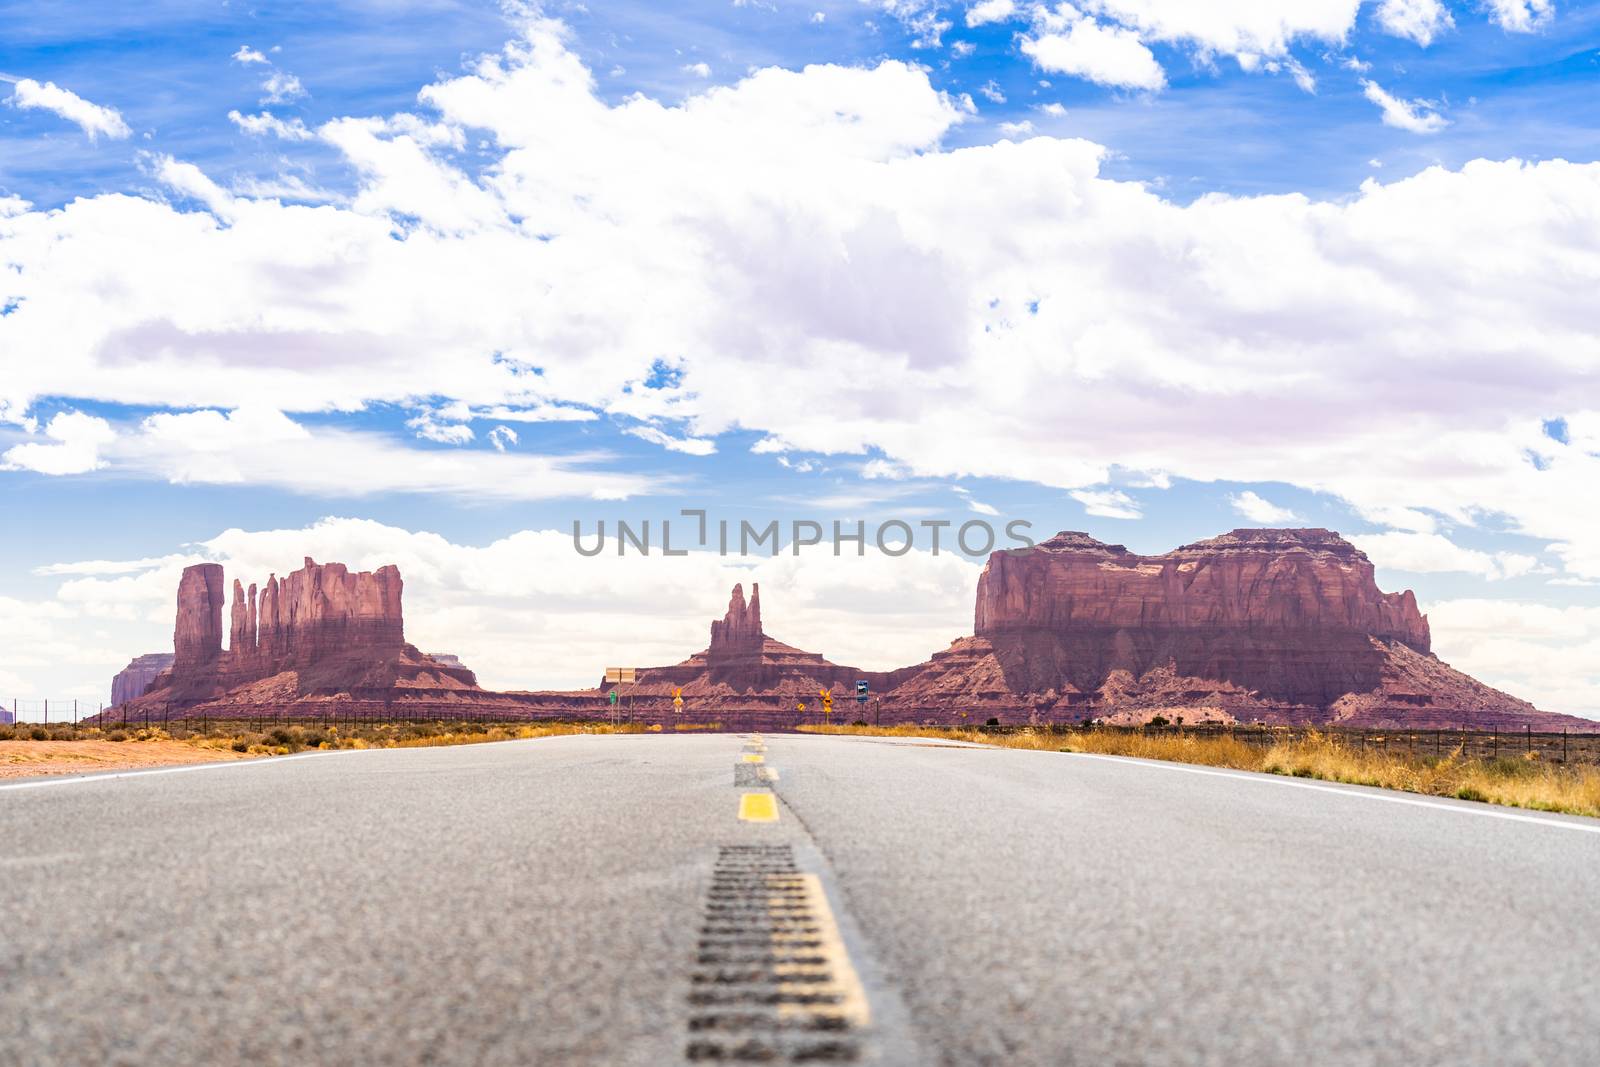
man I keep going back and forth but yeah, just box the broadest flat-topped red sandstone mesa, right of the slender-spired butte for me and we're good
[885,530,1595,729]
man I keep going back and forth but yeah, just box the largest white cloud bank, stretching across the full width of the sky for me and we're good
[0,21,1600,577]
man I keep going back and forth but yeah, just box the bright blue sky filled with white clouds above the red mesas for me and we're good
[0,0,1600,715]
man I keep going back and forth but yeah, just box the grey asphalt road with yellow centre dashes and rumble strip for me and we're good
[0,736,1600,1065]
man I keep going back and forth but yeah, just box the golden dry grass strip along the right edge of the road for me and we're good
[803,726,1600,816]
